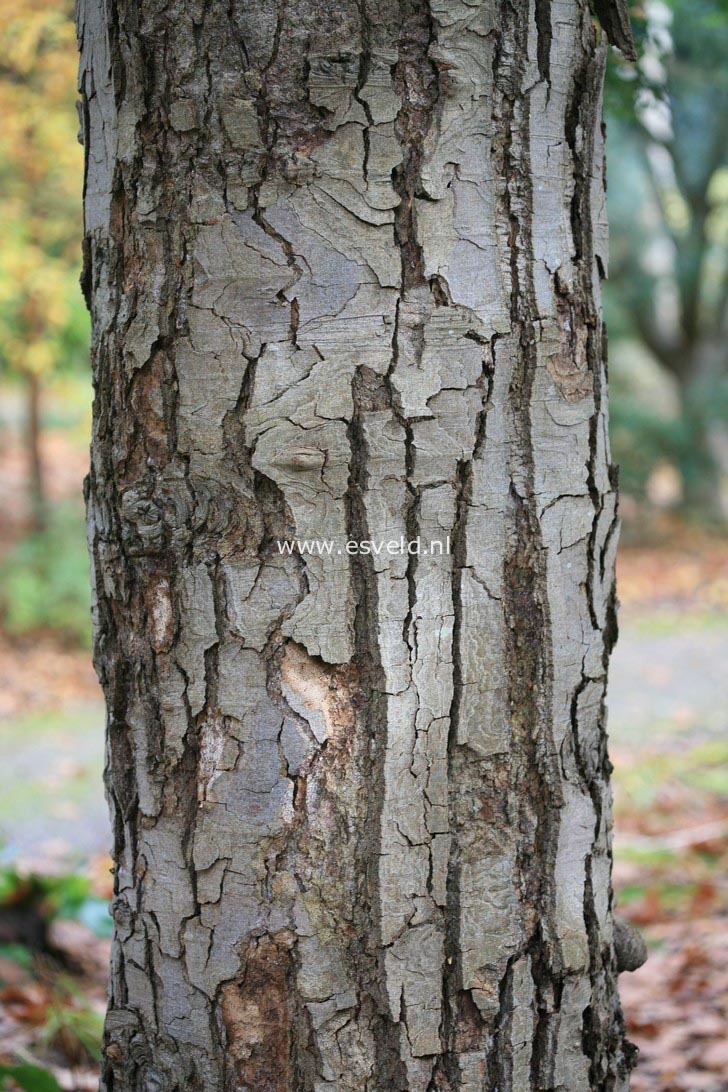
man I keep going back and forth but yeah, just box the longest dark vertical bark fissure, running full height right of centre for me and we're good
[494,3,562,1089]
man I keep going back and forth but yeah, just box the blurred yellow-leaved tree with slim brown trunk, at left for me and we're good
[0,0,88,527]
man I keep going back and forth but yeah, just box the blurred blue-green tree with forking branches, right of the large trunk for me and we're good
[608,0,728,520]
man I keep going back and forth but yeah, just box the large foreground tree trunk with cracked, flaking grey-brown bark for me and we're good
[80,0,630,1092]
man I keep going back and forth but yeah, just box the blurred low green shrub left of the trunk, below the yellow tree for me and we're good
[0,505,91,648]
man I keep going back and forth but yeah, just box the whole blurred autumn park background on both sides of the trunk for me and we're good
[0,0,728,1092]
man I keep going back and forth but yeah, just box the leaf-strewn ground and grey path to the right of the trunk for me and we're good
[608,543,728,1092]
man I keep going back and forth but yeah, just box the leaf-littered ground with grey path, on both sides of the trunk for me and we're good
[0,395,728,1092]
